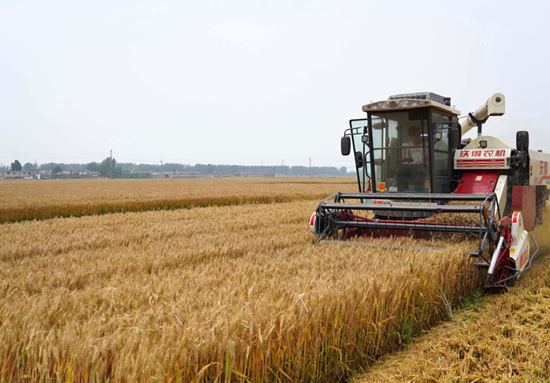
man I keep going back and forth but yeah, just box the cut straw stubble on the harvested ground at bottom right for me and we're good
[354,205,550,383]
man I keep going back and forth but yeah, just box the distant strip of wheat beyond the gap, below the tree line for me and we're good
[0,178,357,223]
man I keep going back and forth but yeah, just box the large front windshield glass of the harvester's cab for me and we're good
[371,109,430,192]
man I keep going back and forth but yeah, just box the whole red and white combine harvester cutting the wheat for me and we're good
[310,93,550,289]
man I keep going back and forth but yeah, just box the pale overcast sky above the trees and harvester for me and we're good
[0,0,550,168]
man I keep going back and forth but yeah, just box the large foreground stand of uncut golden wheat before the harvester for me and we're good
[0,180,479,382]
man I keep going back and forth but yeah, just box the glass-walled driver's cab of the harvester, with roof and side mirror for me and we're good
[342,93,460,198]
